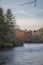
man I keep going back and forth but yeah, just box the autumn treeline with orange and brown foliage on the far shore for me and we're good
[17,27,43,44]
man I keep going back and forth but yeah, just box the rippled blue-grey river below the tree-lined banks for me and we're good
[0,44,43,65]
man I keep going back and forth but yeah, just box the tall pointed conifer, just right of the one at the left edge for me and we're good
[6,9,15,44]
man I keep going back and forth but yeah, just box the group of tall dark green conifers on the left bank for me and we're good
[0,7,16,47]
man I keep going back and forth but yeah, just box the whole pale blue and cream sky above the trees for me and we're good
[0,0,43,30]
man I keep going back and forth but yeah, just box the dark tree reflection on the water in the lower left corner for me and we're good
[0,50,14,65]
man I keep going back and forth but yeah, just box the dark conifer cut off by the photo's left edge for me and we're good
[0,7,5,46]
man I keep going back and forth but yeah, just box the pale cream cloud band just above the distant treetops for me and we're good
[17,19,43,30]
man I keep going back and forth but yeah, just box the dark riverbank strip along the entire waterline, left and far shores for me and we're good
[0,42,43,49]
